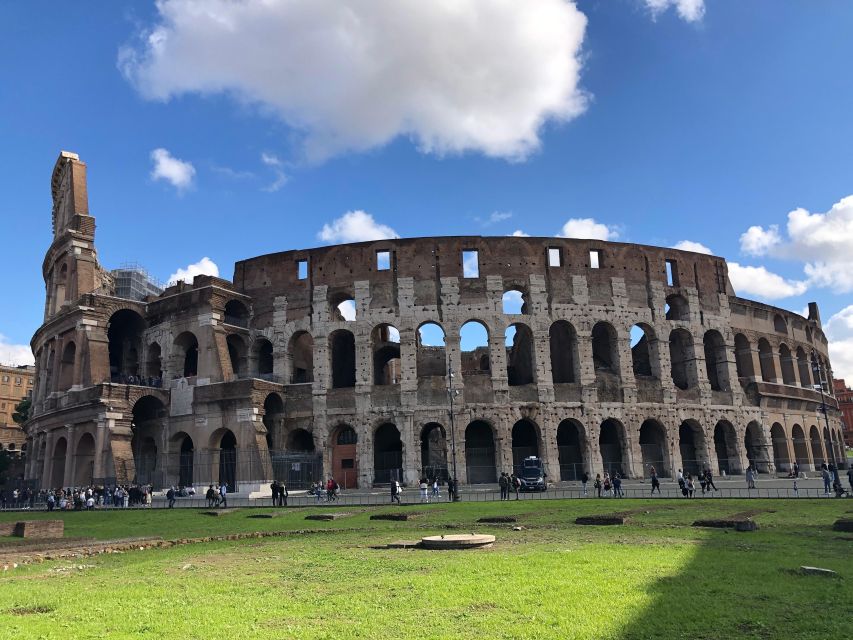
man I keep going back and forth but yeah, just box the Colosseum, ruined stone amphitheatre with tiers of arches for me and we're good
[20,152,845,492]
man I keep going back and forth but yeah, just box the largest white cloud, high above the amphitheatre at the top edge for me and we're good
[118,0,587,161]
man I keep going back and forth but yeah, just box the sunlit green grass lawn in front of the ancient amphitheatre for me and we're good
[0,499,853,640]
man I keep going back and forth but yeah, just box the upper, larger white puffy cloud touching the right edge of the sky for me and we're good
[741,195,853,293]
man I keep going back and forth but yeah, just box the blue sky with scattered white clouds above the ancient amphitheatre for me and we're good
[0,0,853,377]
